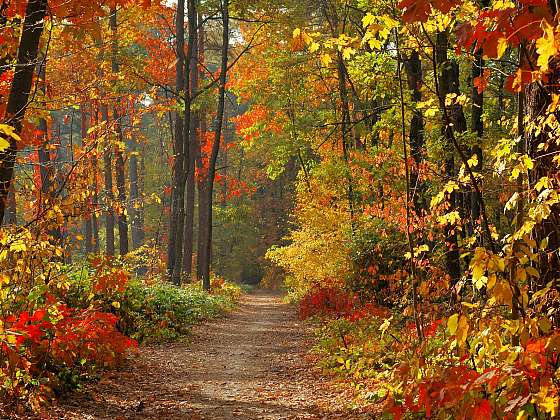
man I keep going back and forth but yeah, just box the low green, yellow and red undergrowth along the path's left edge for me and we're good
[0,228,241,412]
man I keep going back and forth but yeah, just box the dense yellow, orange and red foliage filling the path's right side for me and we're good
[235,0,560,419]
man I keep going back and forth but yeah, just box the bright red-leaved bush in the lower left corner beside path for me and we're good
[0,303,137,407]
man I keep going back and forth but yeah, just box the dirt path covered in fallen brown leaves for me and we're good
[40,291,369,420]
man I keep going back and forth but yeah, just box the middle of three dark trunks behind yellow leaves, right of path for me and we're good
[436,32,466,284]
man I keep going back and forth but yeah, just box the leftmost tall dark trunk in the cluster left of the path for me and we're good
[167,0,186,281]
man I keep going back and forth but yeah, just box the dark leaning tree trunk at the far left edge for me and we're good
[0,0,47,221]
